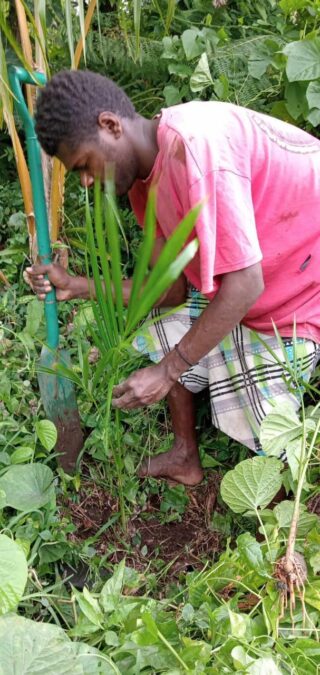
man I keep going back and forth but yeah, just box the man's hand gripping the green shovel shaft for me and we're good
[24,263,76,300]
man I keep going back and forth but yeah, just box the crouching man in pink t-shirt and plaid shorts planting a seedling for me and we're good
[28,71,320,485]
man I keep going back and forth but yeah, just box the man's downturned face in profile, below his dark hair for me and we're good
[58,115,138,196]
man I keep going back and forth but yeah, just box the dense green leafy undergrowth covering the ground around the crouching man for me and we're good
[0,0,320,675]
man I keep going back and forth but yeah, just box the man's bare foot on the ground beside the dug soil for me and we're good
[139,444,203,485]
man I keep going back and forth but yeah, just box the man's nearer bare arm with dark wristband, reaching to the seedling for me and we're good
[113,263,264,409]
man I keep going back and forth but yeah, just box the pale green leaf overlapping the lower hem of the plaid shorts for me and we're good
[260,403,303,456]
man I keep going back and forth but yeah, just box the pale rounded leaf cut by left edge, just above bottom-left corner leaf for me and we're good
[0,534,28,616]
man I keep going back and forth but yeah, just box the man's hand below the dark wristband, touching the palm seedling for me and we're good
[112,363,174,410]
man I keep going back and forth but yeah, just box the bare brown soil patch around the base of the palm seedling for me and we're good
[62,472,221,577]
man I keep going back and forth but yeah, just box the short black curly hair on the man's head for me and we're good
[35,70,136,156]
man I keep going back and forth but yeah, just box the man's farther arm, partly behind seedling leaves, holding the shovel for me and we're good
[26,237,187,307]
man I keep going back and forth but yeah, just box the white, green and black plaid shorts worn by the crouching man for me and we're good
[134,288,320,452]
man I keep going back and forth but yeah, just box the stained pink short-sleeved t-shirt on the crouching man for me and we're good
[129,101,320,342]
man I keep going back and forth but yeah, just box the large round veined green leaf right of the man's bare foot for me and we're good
[221,457,282,513]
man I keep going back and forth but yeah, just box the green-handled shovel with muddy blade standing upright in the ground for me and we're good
[9,66,83,473]
